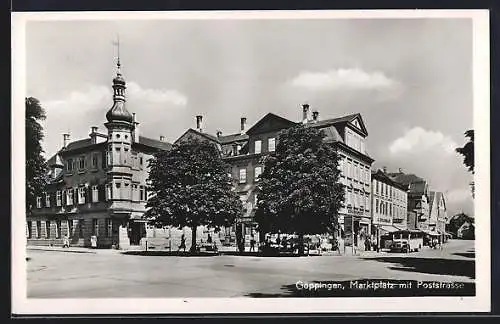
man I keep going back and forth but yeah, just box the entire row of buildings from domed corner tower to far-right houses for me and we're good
[26,59,446,249]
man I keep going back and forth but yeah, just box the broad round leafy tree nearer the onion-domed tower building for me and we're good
[146,139,243,253]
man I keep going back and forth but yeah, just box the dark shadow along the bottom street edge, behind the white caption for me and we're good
[245,279,476,298]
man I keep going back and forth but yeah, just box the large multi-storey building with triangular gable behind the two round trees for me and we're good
[175,104,374,244]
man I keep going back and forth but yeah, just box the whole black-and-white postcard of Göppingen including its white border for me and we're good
[12,10,490,314]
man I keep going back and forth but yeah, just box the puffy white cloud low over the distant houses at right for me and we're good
[389,127,458,154]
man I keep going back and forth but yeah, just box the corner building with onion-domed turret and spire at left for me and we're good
[26,63,171,249]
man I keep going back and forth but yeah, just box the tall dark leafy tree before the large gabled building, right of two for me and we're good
[256,124,344,255]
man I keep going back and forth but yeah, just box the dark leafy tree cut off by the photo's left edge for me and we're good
[25,97,47,213]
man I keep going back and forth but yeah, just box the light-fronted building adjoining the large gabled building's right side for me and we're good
[371,170,408,247]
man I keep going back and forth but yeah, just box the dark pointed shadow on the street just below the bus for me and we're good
[364,257,476,279]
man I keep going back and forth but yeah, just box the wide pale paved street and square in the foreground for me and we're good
[28,240,475,298]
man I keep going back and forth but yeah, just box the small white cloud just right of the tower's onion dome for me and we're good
[127,82,187,106]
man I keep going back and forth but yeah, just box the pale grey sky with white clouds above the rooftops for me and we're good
[26,18,473,215]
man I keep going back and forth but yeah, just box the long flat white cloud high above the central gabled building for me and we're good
[290,68,401,91]
